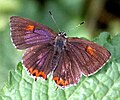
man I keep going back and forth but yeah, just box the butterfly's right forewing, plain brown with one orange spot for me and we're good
[67,38,111,76]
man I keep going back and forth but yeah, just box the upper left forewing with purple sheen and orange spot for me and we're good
[10,16,57,49]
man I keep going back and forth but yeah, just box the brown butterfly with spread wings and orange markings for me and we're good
[10,16,111,88]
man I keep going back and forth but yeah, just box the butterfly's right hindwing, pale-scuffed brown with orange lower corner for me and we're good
[53,50,82,88]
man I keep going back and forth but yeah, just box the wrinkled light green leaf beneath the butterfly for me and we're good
[0,32,120,100]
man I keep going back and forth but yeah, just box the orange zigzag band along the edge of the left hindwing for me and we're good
[29,67,47,79]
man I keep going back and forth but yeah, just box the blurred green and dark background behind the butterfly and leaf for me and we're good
[0,0,120,88]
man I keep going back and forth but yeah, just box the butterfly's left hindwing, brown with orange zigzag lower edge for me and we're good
[23,44,53,79]
